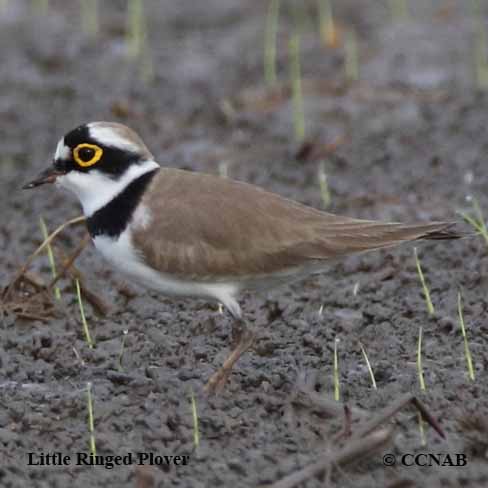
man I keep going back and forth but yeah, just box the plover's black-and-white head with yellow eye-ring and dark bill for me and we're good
[23,122,159,217]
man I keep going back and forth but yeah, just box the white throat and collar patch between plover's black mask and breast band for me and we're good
[56,160,159,217]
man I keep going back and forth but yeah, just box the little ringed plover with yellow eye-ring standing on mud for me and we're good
[23,122,460,393]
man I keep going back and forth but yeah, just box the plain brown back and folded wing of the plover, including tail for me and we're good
[134,168,458,281]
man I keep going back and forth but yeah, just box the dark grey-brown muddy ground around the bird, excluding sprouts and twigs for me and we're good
[0,0,488,488]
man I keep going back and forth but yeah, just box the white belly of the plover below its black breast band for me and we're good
[93,230,239,307]
